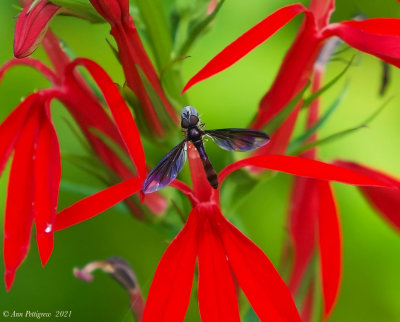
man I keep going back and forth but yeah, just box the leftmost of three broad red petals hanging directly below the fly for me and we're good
[142,209,198,322]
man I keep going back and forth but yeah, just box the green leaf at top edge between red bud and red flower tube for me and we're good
[48,0,105,23]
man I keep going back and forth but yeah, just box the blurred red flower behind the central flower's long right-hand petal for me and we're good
[289,49,400,321]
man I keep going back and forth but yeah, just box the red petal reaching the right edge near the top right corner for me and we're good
[324,18,400,67]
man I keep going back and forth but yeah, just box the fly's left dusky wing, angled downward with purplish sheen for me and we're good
[142,139,186,193]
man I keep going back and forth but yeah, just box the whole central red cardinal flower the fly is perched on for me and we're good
[55,133,391,321]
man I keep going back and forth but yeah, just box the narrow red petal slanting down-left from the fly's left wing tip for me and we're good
[55,178,142,230]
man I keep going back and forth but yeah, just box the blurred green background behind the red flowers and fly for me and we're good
[0,0,400,322]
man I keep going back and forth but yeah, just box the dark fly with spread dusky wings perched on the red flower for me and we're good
[143,106,270,193]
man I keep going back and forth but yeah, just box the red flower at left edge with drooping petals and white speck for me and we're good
[0,59,146,289]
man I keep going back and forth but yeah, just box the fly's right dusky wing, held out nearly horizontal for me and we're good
[204,129,270,152]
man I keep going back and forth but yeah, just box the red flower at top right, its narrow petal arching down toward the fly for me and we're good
[183,0,400,129]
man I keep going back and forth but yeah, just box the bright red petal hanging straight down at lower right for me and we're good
[318,181,342,320]
